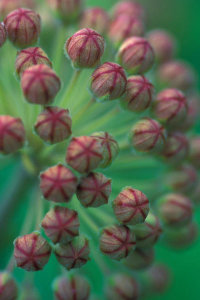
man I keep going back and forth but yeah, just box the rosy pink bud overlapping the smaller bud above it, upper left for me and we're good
[21,64,61,105]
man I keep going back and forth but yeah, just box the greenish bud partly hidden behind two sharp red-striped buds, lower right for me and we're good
[133,213,162,248]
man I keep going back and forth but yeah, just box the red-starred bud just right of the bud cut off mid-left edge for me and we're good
[35,106,72,144]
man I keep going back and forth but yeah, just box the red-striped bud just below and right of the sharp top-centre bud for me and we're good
[90,62,127,100]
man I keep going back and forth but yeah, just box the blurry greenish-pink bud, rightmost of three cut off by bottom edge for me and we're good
[106,274,139,300]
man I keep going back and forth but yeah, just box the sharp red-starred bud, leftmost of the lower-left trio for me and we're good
[14,232,51,271]
